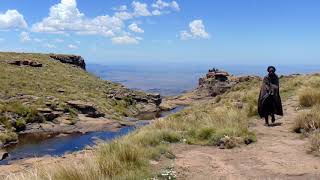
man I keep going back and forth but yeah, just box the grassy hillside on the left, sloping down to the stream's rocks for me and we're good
[0,52,155,145]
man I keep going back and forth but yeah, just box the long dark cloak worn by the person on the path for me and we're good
[258,74,283,118]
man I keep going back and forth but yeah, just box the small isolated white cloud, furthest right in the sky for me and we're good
[180,20,210,40]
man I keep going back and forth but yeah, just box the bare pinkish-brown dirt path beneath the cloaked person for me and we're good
[175,98,320,180]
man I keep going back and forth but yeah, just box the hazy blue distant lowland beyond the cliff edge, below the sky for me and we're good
[87,63,320,95]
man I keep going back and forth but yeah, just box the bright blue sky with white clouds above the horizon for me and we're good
[0,0,320,64]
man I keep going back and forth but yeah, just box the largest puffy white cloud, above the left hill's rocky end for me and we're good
[32,0,124,37]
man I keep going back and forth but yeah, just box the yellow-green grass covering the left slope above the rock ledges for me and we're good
[0,52,142,118]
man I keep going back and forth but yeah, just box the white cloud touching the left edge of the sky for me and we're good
[0,9,28,29]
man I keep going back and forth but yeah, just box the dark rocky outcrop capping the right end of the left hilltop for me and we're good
[50,54,86,70]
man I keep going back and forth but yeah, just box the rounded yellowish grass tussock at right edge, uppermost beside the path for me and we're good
[299,88,320,107]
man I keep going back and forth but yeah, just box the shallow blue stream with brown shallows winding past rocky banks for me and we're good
[0,106,184,165]
